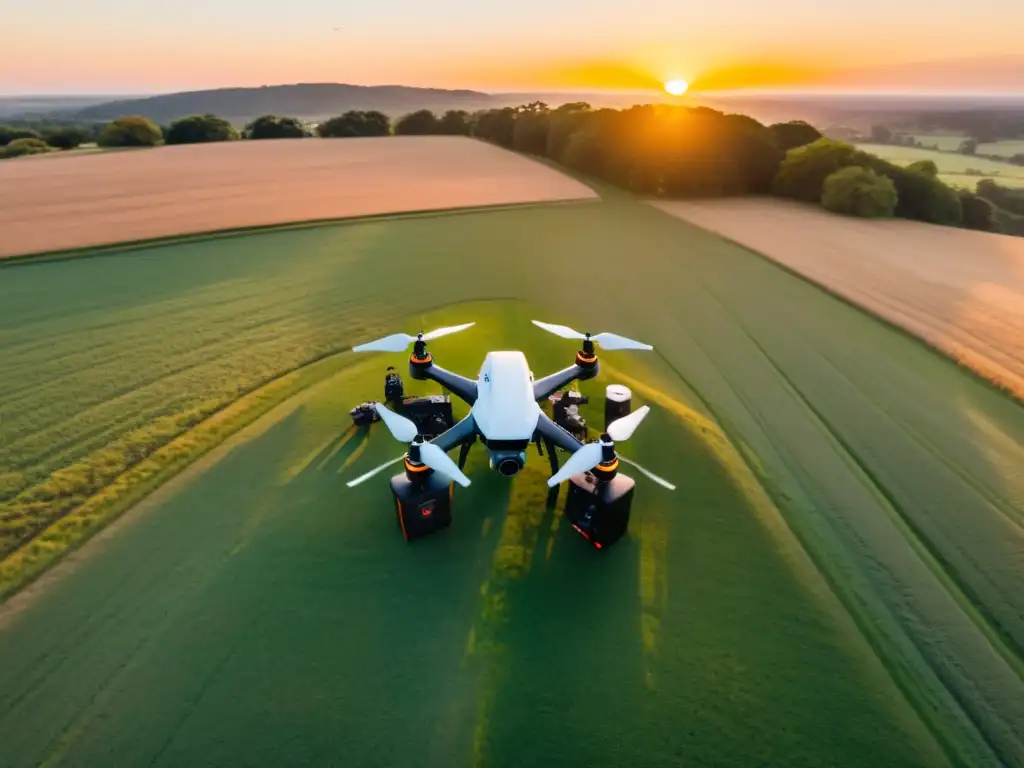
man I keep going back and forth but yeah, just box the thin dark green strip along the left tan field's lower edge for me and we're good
[0,196,601,269]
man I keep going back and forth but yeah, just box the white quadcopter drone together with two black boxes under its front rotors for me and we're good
[347,321,675,549]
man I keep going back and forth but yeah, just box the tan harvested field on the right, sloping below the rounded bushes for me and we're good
[653,200,1024,397]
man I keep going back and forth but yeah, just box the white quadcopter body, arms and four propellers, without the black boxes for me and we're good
[348,321,675,488]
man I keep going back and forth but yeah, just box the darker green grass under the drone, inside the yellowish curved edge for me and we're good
[0,304,944,766]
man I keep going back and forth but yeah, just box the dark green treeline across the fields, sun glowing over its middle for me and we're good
[0,102,1024,234]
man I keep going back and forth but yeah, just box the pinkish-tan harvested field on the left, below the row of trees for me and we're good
[0,136,595,258]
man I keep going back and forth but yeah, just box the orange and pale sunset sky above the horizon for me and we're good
[0,0,1024,94]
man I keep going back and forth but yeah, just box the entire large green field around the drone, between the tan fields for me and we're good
[0,196,1024,767]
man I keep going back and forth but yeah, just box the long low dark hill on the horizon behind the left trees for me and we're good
[62,83,507,123]
